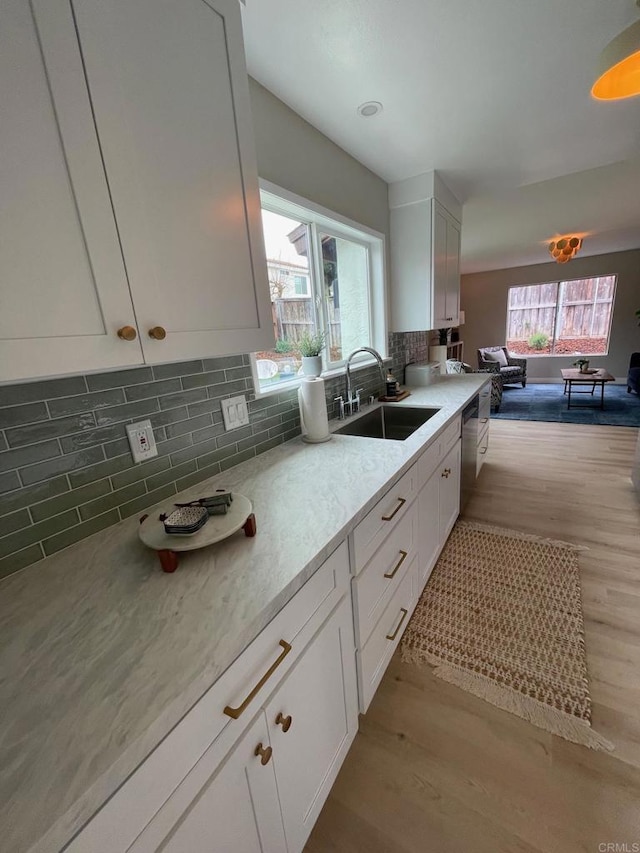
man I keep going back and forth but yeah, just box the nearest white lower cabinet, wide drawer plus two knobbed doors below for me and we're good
[66,543,358,853]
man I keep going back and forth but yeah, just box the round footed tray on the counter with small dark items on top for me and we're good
[138,489,257,572]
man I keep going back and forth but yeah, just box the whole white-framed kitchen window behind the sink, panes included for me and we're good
[252,185,386,396]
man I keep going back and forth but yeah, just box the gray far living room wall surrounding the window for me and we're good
[460,249,640,382]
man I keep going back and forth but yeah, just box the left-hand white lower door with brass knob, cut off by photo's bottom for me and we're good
[130,713,287,853]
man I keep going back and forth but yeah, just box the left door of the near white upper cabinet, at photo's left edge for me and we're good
[0,0,142,381]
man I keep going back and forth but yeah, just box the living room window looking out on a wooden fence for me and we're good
[506,275,616,356]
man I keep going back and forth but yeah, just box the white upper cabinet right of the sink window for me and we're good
[389,172,461,332]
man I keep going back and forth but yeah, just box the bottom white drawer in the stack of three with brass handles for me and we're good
[357,548,419,714]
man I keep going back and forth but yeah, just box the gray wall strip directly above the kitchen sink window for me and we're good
[249,78,389,238]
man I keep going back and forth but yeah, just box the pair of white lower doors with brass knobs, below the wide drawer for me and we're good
[129,598,358,853]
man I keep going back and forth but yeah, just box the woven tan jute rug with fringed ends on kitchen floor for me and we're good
[402,521,613,749]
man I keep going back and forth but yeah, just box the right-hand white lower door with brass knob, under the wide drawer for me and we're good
[264,597,358,853]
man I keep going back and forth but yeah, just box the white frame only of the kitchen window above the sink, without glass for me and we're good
[249,179,388,398]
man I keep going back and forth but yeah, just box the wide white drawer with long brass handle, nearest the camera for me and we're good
[65,543,350,853]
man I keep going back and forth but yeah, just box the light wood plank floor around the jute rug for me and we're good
[306,420,640,853]
